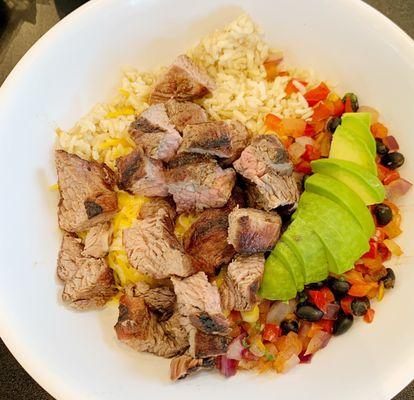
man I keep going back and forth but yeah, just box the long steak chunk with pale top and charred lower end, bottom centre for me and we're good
[171,272,230,358]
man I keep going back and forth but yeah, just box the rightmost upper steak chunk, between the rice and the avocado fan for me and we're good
[233,135,299,211]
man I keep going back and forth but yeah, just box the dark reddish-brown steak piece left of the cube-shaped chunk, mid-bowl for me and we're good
[183,208,236,275]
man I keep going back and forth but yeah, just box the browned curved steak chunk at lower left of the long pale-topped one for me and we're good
[115,290,188,358]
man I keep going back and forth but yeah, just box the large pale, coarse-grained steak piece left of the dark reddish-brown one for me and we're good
[123,208,194,279]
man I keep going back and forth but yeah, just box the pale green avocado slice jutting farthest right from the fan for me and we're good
[311,158,385,205]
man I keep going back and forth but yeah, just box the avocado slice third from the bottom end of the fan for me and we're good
[282,218,328,285]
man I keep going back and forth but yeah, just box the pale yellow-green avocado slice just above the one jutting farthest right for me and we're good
[329,125,377,174]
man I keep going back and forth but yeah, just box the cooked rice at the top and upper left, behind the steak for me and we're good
[57,15,313,168]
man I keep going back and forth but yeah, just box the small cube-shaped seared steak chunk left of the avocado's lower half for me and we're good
[228,208,282,253]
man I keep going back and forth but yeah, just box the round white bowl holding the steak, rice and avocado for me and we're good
[0,0,414,400]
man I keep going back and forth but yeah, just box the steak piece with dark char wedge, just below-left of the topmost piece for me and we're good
[130,104,182,161]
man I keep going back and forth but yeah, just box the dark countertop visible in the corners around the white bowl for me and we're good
[0,0,414,400]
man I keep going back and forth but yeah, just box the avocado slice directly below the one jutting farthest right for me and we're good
[305,173,375,237]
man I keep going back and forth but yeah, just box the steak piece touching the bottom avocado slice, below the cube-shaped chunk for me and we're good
[220,254,265,311]
